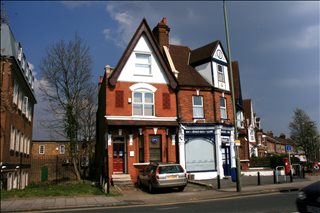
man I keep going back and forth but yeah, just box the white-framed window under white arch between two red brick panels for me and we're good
[132,92,154,116]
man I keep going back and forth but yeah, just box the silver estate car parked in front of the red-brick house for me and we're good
[138,163,188,193]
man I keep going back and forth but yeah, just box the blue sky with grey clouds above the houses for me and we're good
[4,1,320,140]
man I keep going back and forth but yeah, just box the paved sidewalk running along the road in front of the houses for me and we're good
[1,176,320,212]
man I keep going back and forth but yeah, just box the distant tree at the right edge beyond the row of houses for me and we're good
[289,108,320,162]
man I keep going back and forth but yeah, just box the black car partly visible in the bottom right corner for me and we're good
[296,181,320,212]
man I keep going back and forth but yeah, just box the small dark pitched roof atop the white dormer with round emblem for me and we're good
[190,40,228,66]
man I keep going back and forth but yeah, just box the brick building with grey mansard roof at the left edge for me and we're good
[0,23,36,190]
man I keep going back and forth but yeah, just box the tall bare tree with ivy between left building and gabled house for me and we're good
[40,34,95,180]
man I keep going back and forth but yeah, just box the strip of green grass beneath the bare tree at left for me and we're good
[1,182,116,199]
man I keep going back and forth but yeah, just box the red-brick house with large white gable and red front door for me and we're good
[96,19,178,185]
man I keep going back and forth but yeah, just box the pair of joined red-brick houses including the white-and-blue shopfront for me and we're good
[96,18,240,185]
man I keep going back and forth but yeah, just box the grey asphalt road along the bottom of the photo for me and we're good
[38,192,297,213]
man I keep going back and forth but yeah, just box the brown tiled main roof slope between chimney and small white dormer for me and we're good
[169,45,211,87]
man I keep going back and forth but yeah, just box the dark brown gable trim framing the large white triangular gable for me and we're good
[109,19,178,89]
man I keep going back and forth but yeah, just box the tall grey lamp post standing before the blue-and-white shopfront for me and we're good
[223,0,241,192]
